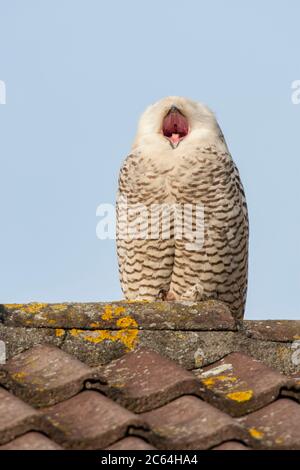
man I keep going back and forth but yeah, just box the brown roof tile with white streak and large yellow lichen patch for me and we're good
[194,353,288,416]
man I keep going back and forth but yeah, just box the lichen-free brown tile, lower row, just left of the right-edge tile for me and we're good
[137,396,243,450]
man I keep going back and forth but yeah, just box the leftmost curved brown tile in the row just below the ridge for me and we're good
[1,344,92,406]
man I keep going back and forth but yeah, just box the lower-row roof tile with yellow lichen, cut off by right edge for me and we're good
[239,398,300,450]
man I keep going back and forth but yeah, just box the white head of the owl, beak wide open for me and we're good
[133,96,220,150]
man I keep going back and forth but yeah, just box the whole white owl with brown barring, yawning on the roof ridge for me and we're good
[117,97,248,318]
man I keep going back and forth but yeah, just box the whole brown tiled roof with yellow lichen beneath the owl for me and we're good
[0,301,300,450]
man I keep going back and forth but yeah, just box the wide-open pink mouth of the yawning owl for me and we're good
[162,106,189,148]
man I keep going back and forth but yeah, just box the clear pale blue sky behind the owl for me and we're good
[0,0,300,319]
